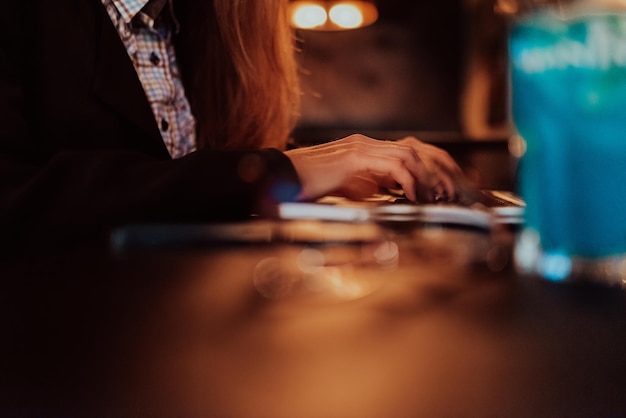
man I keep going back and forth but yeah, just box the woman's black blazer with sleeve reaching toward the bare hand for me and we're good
[0,0,299,255]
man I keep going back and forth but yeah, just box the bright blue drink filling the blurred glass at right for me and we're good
[510,14,626,259]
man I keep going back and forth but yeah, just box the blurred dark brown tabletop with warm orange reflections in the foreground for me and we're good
[0,220,626,418]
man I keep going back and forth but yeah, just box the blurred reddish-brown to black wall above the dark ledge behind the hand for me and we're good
[298,0,506,140]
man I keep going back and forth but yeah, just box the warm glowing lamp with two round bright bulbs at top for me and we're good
[289,0,378,31]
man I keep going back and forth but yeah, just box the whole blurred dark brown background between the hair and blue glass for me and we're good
[294,0,514,190]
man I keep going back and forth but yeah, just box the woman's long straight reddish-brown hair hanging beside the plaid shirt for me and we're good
[175,0,300,149]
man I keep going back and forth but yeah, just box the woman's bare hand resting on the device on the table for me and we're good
[286,135,463,202]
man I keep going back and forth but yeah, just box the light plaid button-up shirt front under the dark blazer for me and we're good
[101,0,196,158]
